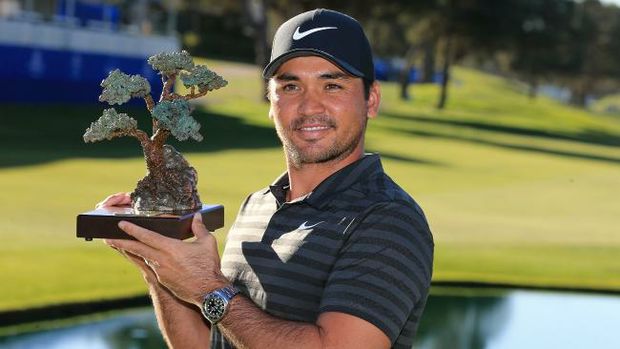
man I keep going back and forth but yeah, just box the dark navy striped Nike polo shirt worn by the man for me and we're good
[211,154,434,348]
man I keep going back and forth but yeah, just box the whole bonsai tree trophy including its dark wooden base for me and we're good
[77,51,228,241]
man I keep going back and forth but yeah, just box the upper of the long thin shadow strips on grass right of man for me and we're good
[381,112,620,147]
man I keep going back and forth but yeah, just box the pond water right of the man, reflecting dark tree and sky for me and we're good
[414,291,620,349]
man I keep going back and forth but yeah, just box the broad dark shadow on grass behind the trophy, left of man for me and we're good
[0,105,281,168]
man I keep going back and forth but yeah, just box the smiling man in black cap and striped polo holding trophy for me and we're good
[103,9,433,348]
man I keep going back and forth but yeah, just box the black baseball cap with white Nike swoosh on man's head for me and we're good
[263,9,375,81]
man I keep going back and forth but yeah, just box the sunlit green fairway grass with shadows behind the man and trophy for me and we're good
[0,61,620,310]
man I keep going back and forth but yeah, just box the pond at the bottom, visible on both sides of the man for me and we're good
[0,288,620,349]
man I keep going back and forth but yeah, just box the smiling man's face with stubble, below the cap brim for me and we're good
[269,56,379,168]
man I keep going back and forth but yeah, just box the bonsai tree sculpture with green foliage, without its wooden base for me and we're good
[84,51,227,214]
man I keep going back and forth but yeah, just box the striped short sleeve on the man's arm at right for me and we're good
[319,202,433,344]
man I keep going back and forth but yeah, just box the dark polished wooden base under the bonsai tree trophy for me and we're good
[77,205,224,241]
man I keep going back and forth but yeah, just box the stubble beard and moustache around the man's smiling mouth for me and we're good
[276,117,366,168]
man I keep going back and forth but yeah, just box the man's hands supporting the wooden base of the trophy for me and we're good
[104,213,230,306]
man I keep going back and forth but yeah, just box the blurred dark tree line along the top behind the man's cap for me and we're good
[173,0,620,108]
